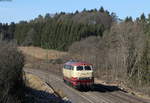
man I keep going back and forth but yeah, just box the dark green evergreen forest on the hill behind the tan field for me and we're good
[0,7,116,50]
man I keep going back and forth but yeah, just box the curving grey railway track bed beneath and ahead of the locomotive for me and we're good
[24,69,150,103]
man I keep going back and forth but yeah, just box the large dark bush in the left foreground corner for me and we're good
[0,42,24,103]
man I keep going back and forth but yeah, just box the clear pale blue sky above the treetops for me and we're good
[0,0,150,23]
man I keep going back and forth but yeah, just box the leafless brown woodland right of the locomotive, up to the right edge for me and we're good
[69,14,150,95]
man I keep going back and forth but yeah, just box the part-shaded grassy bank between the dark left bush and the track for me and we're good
[25,73,61,103]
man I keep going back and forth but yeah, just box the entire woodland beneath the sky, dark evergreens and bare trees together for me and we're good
[0,7,150,95]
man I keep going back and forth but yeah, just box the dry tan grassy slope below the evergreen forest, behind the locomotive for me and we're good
[18,47,68,73]
